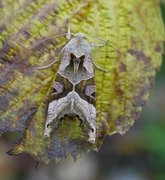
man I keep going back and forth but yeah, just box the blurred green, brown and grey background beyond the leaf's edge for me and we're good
[0,1,165,180]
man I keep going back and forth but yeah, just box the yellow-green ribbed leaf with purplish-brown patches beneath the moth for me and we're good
[0,0,164,162]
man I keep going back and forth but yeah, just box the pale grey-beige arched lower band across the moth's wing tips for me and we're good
[44,91,96,143]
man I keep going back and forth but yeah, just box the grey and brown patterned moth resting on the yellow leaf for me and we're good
[35,20,106,143]
